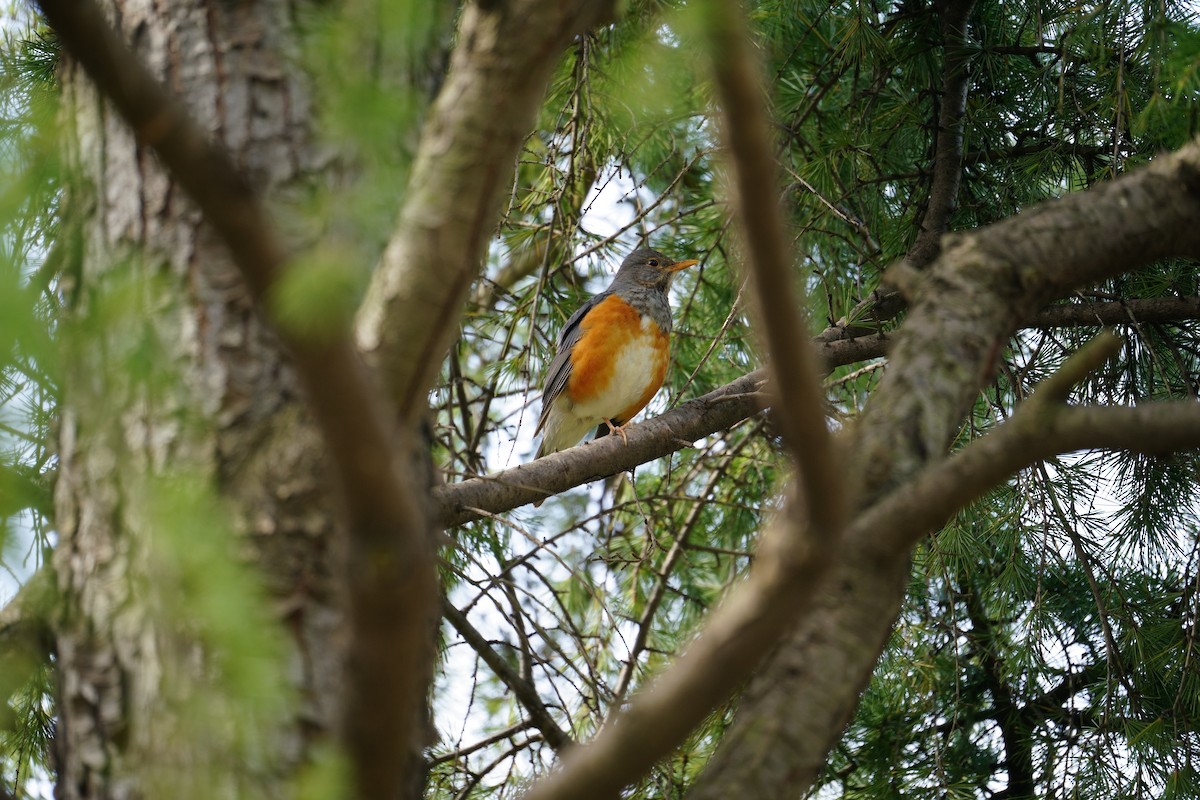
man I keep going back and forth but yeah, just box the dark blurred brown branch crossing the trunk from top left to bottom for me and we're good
[34,0,438,798]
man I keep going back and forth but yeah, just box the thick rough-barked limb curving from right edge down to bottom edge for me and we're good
[698,123,1200,798]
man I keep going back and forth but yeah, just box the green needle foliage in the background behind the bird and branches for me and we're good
[436,0,1200,799]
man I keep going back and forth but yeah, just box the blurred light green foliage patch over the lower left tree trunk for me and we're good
[128,473,295,798]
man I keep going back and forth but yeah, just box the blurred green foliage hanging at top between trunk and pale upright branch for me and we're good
[295,0,456,307]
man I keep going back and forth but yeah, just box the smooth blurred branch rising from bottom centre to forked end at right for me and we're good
[527,326,1200,800]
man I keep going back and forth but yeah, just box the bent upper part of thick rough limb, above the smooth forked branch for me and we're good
[856,142,1200,498]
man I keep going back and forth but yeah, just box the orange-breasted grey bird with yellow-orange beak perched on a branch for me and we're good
[534,248,700,458]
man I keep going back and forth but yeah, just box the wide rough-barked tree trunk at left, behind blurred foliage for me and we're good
[54,0,341,798]
